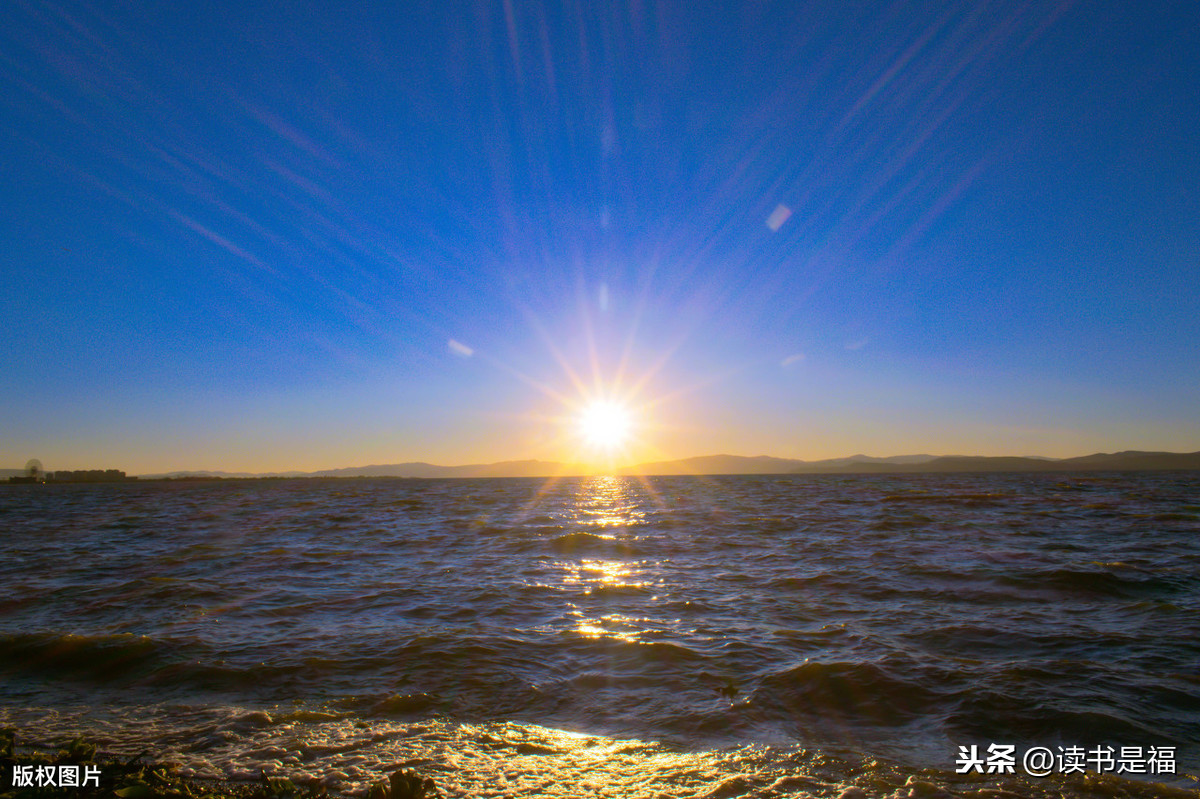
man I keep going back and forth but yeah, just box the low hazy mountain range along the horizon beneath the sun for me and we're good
[119,451,1200,480]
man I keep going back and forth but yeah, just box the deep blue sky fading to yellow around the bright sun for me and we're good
[0,0,1200,473]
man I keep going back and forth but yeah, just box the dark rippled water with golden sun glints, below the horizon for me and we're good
[0,473,1200,799]
